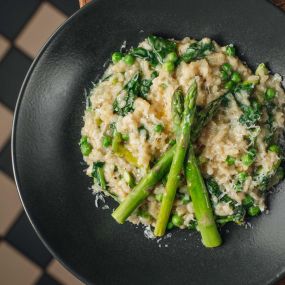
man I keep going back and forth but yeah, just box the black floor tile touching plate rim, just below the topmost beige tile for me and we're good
[0,47,32,110]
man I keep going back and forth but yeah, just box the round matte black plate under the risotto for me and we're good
[13,0,285,285]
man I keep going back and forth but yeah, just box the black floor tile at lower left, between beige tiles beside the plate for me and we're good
[5,212,52,268]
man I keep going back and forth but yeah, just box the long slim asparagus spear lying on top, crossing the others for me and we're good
[154,80,197,236]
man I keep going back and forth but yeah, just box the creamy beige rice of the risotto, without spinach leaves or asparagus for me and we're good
[82,38,285,228]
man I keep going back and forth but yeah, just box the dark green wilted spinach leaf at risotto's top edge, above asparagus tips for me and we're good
[147,36,176,64]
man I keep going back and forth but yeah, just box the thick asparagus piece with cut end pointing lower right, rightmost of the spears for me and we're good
[185,146,222,247]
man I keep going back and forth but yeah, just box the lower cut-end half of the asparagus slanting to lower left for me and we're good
[112,146,175,224]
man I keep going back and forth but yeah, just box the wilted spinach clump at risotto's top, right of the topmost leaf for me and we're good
[181,41,215,63]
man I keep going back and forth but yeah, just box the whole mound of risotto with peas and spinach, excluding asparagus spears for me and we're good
[80,36,285,242]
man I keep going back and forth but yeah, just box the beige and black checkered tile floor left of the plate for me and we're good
[0,0,285,285]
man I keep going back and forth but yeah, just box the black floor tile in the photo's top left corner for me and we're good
[0,0,41,39]
